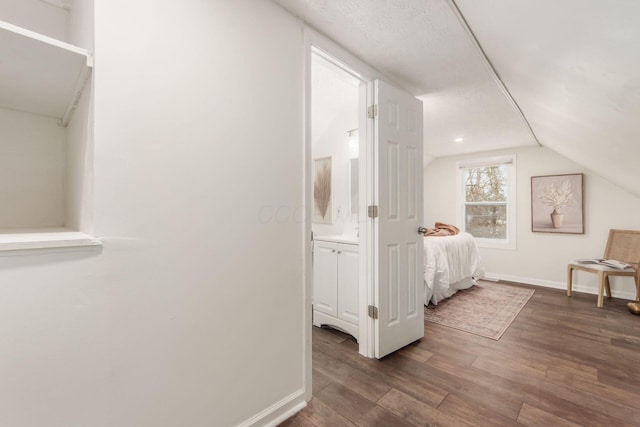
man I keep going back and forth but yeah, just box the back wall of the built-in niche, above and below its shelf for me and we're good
[0,0,68,229]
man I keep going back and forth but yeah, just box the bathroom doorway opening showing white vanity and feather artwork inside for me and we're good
[310,48,367,352]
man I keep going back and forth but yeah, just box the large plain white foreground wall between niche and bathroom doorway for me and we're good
[0,0,304,426]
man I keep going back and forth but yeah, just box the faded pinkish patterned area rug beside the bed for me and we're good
[424,280,534,340]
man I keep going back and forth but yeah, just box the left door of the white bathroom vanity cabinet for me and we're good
[313,240,338,317]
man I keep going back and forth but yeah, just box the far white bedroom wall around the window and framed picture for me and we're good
[424,147,640,297]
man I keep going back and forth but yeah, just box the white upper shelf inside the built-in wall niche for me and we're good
[0,21,93,126]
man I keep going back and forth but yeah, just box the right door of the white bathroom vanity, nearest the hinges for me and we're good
[338,243,360,325]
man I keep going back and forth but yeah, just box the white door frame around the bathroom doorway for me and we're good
[303,27,382,401]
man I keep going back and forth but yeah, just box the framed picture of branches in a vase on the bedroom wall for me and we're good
[531,173,584,234]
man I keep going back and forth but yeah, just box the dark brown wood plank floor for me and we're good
[282,280,640,426]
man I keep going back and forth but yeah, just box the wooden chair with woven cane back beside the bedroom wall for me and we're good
[567,230,640,307]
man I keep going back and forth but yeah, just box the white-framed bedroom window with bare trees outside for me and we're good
[458,156,516,249]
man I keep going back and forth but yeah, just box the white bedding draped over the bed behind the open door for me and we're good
[424,233,484,305]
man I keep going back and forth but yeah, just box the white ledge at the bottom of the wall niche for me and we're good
[0,228,102,255]
